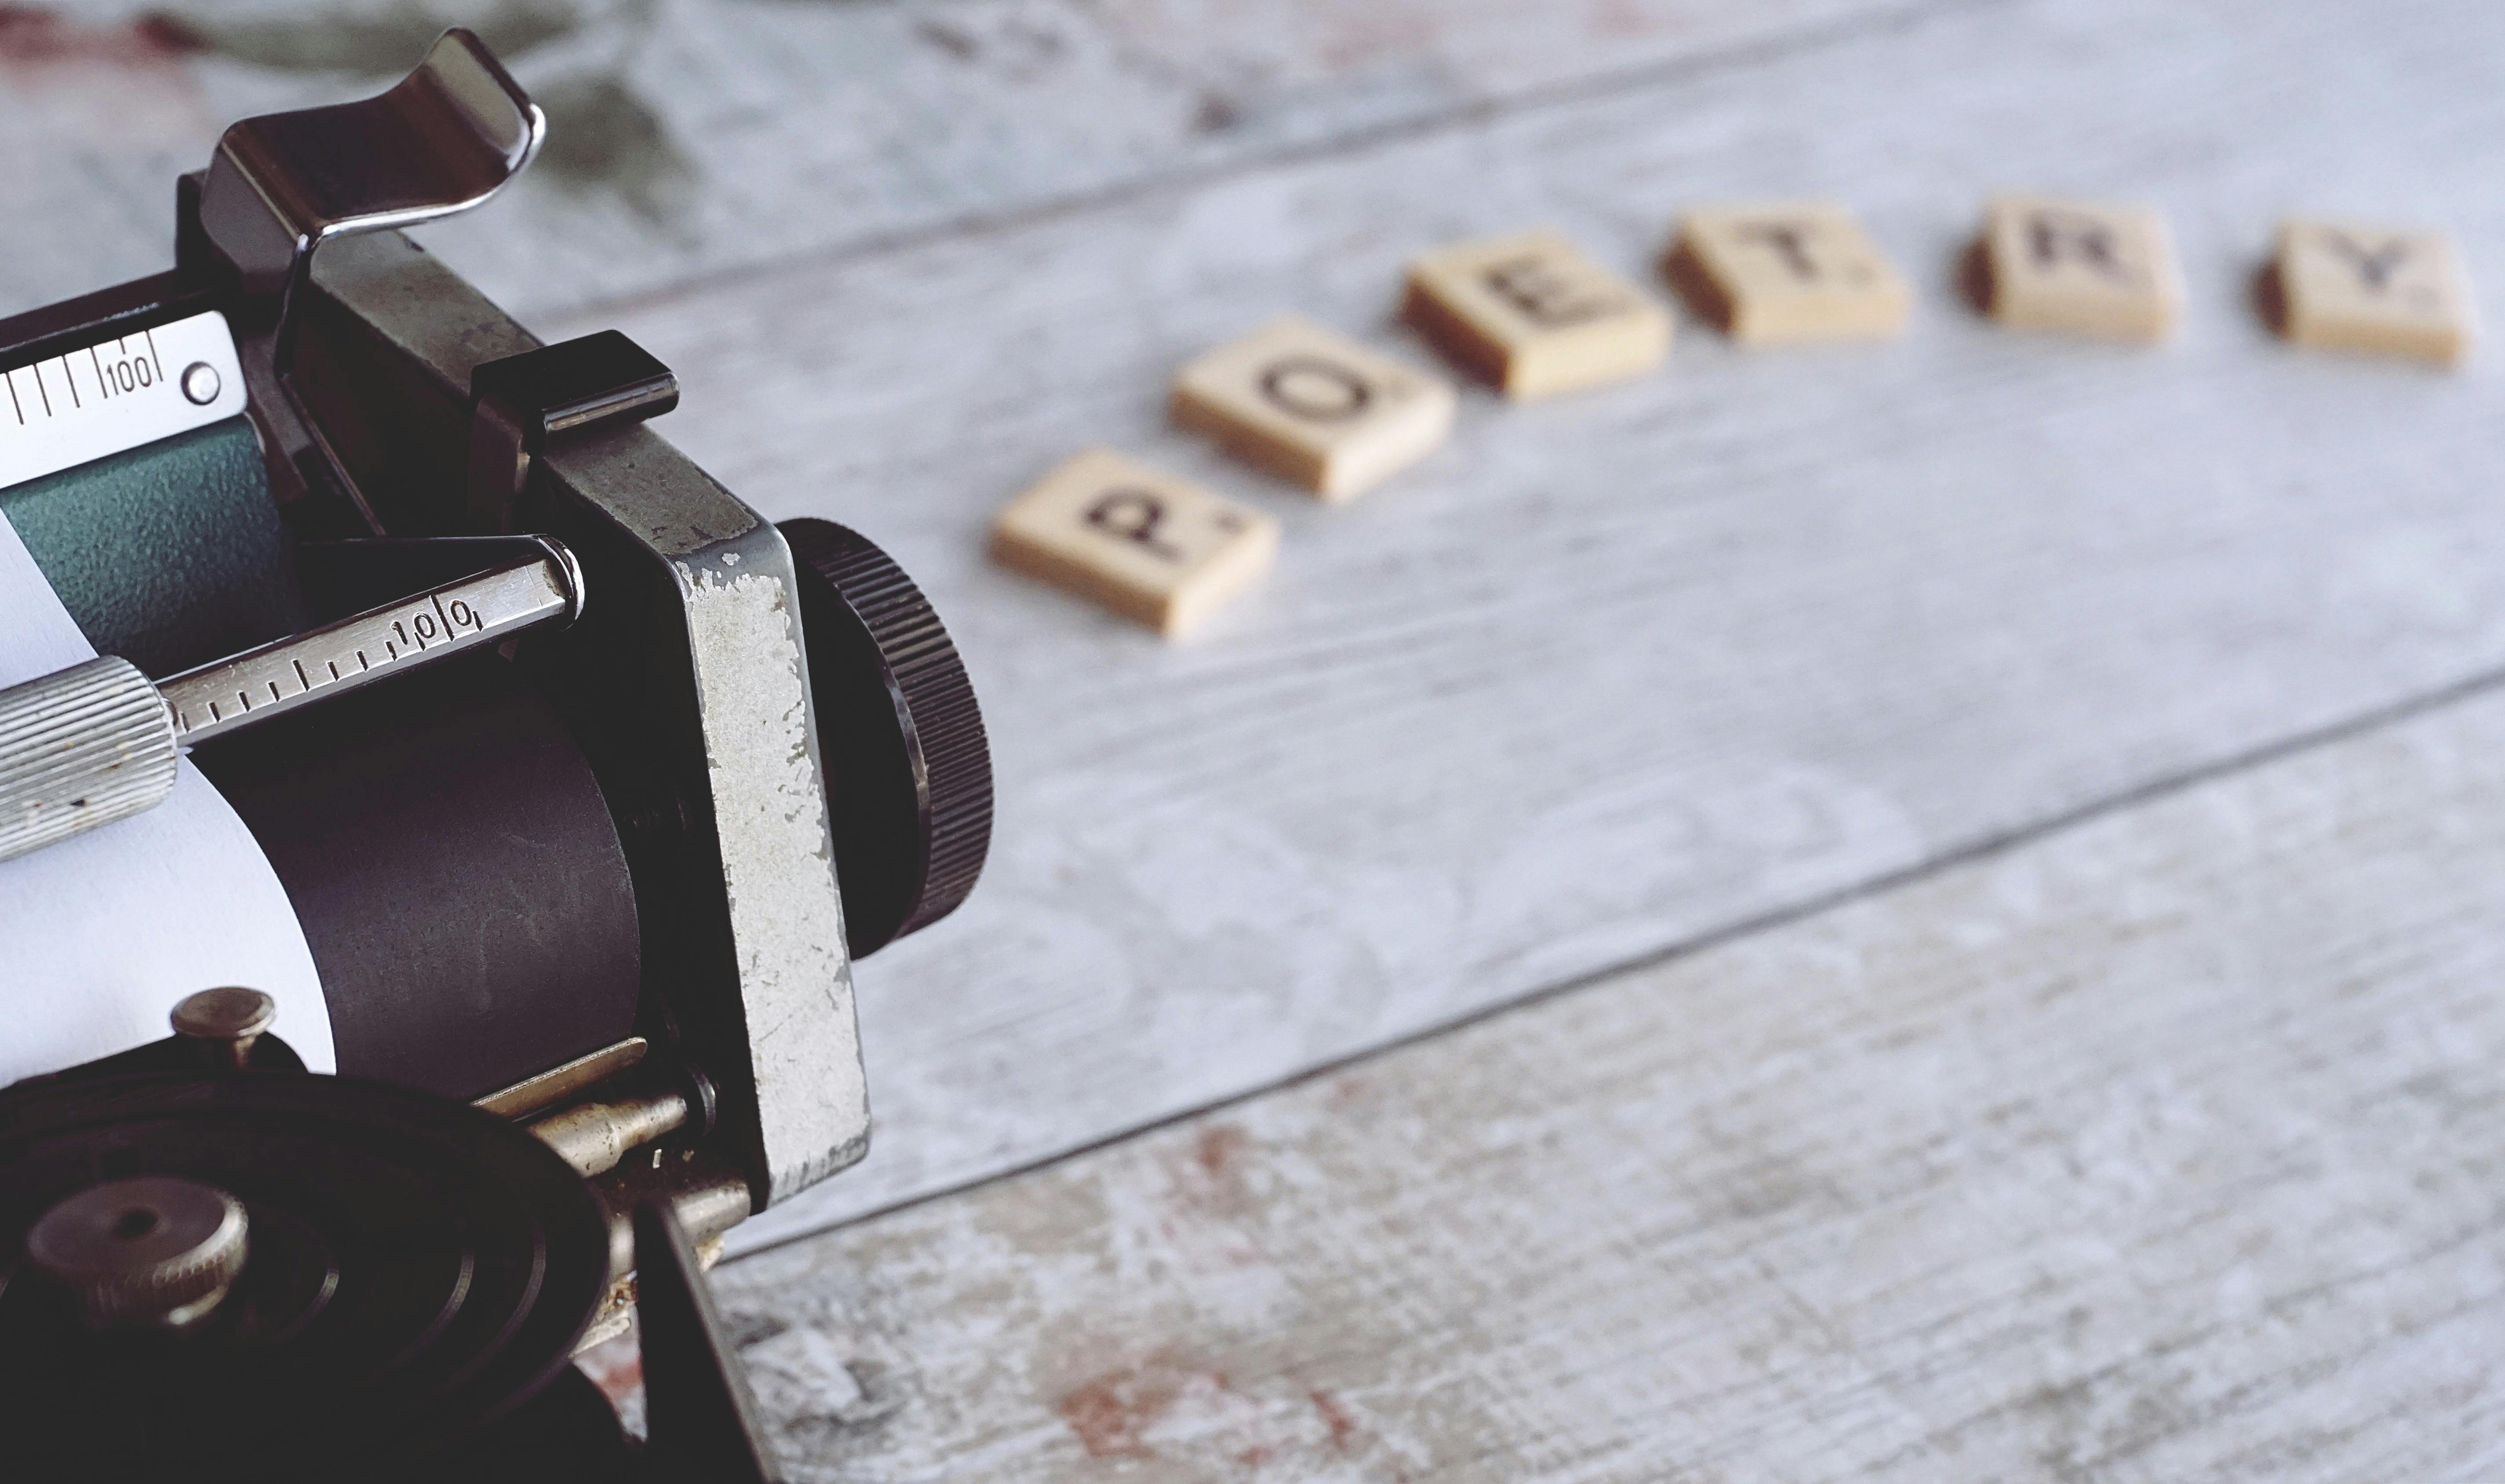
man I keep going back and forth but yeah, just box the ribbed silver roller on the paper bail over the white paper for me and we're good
[0,654,180,860]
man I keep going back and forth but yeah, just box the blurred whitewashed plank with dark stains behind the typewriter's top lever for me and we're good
[0,0,1934,318]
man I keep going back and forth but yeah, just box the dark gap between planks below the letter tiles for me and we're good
[727,667,2505,1263]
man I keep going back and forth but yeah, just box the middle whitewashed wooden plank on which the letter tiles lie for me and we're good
[559,0,2505,1241]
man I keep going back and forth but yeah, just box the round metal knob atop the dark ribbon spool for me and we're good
[25,1176,246,1328]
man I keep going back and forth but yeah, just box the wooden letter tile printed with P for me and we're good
[992,449,1277,634]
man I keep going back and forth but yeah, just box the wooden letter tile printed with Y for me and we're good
[2280,221,2475,366]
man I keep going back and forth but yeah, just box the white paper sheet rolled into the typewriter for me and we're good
[0,519,336,1083]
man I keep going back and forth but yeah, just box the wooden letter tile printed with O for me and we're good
[1175,316,1453,499]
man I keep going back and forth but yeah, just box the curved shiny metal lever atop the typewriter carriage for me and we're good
[200,28,549,293]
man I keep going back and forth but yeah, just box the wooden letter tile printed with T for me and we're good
[1669,200,1914,346]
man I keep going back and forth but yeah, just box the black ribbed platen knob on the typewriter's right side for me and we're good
[777,519,992,957]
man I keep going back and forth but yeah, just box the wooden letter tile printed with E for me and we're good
[1400,231,1671,401]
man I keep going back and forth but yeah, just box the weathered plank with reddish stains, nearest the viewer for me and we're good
[714,692,2505,1484]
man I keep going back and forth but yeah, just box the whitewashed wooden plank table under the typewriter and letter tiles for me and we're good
[15,0,2505,1481]
